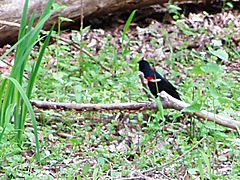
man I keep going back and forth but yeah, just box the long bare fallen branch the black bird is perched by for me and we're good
[31,91,240,129]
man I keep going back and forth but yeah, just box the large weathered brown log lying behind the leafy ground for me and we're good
[0,0,218,46]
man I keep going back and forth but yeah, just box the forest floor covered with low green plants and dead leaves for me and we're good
[0,3,240,179]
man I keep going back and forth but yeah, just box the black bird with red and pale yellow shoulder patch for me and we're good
[138,60,181,100]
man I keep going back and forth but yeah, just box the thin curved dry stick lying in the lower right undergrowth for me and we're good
[142,137,206,174]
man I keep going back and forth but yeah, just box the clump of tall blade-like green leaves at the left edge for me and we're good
[0,0,53,159]
